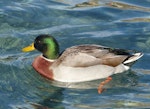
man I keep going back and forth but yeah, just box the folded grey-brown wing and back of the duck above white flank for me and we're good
[56,45,142,67]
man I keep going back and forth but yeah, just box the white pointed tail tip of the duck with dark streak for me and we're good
[123,53,143,66]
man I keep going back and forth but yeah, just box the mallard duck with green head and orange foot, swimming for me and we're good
[22,34,143,93]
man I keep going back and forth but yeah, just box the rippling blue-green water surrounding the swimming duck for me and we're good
[0,0,150,109]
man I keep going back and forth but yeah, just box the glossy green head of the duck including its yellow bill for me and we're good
[23,34,59,59]
